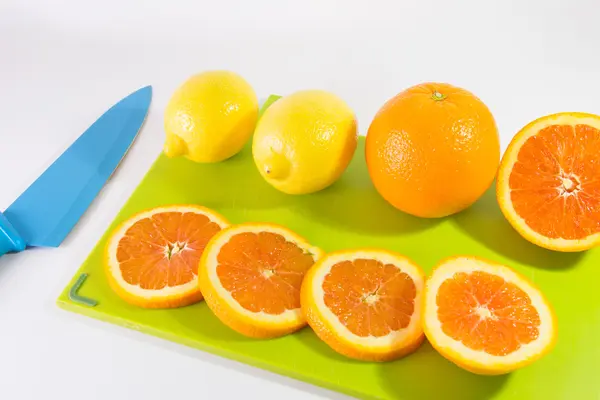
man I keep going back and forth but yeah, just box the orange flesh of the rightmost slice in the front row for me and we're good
[436,271,540,356]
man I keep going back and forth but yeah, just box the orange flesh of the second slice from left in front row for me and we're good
[217,232,315,315]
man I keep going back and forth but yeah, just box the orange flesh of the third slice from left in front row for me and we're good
[322,259,417,337]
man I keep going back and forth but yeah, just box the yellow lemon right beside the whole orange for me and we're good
[252,90,358,194]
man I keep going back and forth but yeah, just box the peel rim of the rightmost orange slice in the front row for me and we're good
[422,255,558,375]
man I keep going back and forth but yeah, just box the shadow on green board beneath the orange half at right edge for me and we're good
[453,182,585,270]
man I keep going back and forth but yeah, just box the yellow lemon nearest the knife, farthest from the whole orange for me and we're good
[164,70,258,163]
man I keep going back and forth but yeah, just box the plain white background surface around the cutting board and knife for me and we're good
[0,0,600,400]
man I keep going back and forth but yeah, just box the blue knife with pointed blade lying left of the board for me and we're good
[0,86,152,255]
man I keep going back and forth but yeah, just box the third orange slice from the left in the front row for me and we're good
[302,249,425,361]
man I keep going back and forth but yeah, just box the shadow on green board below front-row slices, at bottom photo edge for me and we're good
[381,341,510,400]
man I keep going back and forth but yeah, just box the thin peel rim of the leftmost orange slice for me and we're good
[104,204,229,308]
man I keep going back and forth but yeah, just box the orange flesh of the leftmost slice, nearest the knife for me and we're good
[117,212,221,290]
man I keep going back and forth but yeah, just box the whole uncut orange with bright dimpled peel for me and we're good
[365,83,500,218]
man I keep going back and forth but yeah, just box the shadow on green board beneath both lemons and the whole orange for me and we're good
[155,138,442,235]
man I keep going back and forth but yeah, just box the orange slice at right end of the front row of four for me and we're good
[423,257,557,375]
